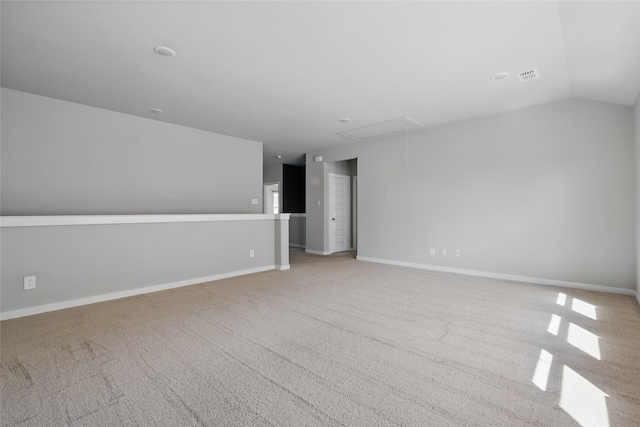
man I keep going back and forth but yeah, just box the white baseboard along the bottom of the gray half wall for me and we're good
[0,265,278,320]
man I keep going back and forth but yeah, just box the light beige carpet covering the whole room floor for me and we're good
[0,252,640,427]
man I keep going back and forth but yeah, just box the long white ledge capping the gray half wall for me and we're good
[0,214,290,228]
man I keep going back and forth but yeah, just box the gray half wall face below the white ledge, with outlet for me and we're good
[0,220,278,313]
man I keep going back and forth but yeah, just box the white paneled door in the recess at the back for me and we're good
[329,173,351,253]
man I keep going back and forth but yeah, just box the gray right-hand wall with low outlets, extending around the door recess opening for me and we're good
[307,100,636,289]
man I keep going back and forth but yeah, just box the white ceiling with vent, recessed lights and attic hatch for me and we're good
[1,0,640,164]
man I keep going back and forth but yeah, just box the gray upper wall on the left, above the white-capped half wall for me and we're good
[0,89,262,215]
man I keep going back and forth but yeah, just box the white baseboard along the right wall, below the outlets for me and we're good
[356,256,640,303]
